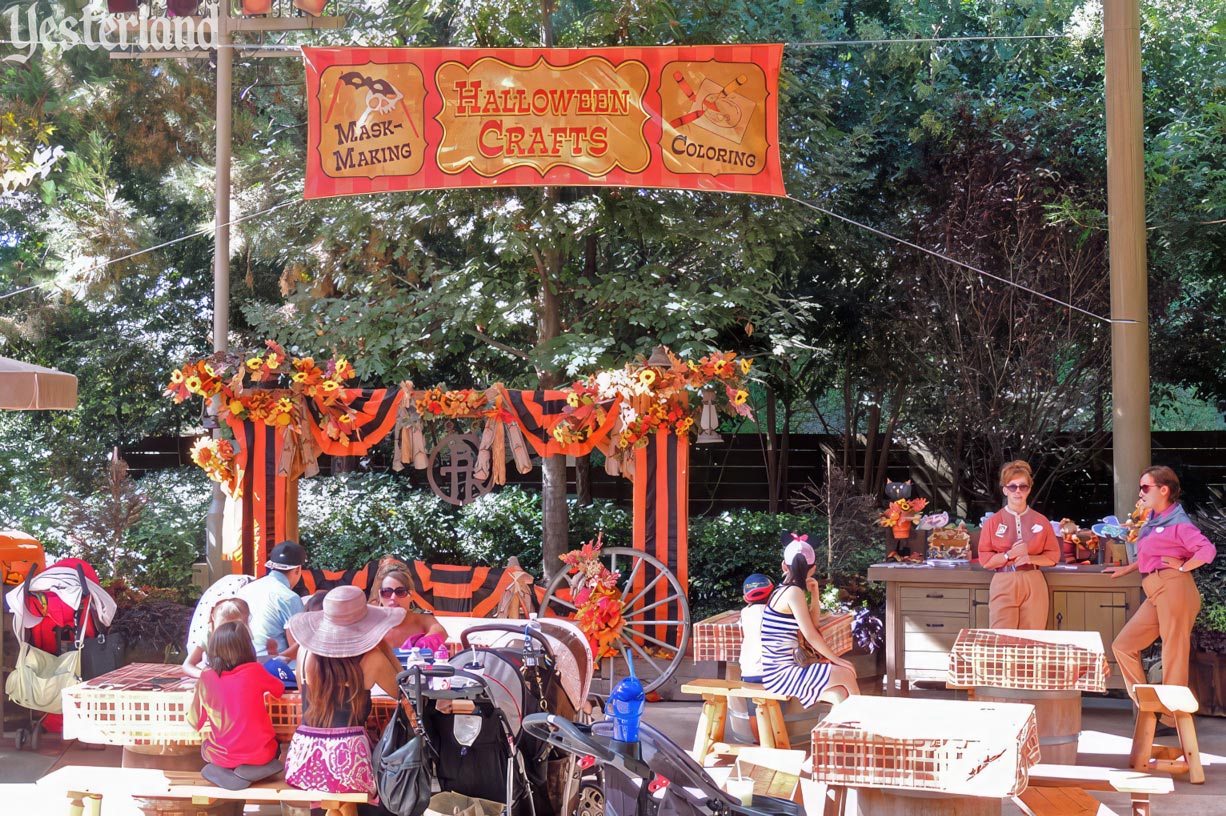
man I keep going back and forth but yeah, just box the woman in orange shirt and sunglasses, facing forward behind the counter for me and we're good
[980,459,1060,629]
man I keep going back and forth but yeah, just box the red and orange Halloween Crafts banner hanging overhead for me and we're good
[303,45,786,198]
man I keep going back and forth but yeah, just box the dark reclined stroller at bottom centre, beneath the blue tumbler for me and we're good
[524,713,804,816]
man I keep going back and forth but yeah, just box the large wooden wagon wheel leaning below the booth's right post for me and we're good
[541,546,690,695]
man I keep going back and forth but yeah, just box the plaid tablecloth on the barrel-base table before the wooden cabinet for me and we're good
[949,629,1110,691]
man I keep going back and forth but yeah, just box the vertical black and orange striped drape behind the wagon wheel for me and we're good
[634,430,689,640]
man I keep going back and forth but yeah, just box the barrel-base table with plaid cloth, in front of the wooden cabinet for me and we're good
[946,629,1111,765]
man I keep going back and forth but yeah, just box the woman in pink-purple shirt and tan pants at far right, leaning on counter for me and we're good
[1105,466,1217,725]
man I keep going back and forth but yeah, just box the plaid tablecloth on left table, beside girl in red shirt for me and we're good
[63,663,396,745]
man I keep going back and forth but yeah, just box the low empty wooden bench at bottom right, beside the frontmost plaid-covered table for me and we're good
[1013,763,1175,816]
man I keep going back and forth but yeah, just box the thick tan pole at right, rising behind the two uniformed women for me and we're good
[1102,0,1150,518]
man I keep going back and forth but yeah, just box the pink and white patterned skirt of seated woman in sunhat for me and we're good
[286,725,378,799]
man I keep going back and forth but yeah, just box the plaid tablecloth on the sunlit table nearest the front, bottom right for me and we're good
[813,696,1038,799]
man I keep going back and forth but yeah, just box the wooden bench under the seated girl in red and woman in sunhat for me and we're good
[38,765,370,816]
